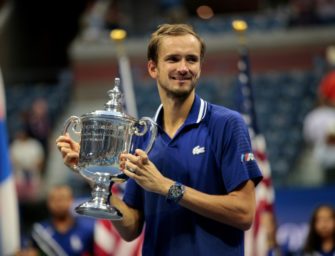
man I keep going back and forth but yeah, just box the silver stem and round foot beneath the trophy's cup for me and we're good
[75,173,122,220]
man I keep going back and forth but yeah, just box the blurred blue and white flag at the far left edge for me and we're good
[0,67,20,255]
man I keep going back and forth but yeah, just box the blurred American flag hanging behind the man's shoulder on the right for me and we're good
[237,47,275,256]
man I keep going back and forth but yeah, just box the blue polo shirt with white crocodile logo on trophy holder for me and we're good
[123,96,262,256]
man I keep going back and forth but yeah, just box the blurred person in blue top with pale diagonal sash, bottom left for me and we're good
[18,185,94,256]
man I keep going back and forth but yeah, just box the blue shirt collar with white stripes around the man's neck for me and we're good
[154,95,208,125]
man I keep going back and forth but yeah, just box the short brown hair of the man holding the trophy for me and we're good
[147,24,206,63]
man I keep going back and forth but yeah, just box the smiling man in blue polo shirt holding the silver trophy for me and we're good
[57,24,262,256]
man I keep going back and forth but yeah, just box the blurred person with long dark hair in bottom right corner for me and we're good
[303,205,335,256]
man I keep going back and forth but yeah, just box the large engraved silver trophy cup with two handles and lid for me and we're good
[63,78,157,220]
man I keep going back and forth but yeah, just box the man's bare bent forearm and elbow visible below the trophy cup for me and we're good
[111,196,143,242]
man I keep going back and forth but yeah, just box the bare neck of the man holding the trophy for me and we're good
[162,91,195,138]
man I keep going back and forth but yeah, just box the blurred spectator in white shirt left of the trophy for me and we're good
[10,129,45,203]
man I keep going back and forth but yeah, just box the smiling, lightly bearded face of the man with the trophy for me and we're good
[148,34,201,99]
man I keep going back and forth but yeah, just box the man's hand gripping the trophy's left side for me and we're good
[56,134,80,171]
